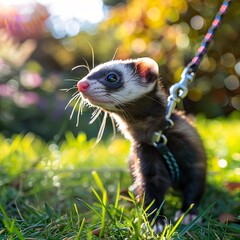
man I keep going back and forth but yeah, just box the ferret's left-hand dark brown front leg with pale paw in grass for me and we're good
[137,146,171,233]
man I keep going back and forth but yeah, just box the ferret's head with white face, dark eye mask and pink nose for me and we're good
[77,58,159,111]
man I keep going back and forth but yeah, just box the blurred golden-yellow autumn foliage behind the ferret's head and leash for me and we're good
[100,0,240,117]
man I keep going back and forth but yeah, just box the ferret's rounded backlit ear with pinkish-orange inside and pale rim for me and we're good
[135,57,159,82]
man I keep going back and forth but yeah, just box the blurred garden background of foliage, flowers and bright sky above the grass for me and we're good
[0,0,240,141]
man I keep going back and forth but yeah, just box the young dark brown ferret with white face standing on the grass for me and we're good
[74,57,206,233]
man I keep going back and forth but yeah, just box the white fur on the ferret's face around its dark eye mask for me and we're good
[78,58,158,111]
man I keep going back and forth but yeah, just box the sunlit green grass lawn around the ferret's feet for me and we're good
[0,113,240,240]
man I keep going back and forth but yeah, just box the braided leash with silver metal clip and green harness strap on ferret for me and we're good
[150,0,233,182]
